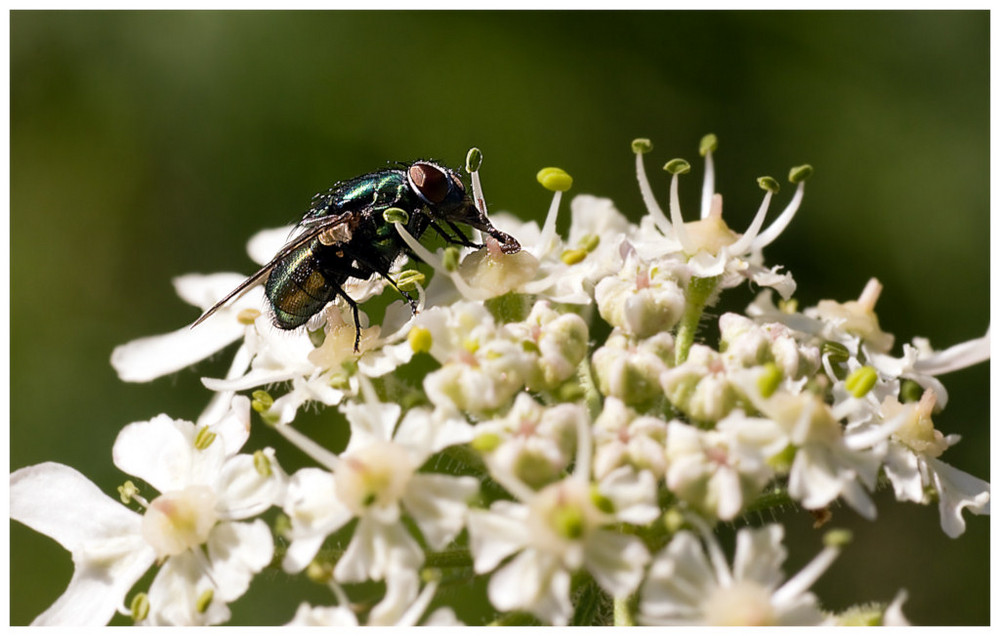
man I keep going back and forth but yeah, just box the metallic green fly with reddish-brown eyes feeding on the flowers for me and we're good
[195,161,521,350]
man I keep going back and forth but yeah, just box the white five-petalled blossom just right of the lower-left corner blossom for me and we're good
[283,401,478,582]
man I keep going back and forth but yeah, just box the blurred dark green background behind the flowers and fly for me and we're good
[10,11,989,624]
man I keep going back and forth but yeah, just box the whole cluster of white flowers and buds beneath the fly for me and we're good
[10,136,990,625]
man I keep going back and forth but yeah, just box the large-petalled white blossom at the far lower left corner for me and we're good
[11,397,284,625]
